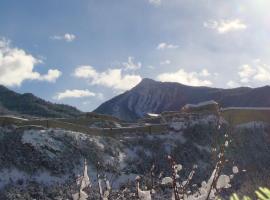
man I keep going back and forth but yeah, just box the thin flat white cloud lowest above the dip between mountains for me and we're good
[55,90,96,100]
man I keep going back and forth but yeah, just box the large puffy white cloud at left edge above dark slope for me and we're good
[0,39,61,86]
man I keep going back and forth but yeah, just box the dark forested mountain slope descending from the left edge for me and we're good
[0,86,82,117]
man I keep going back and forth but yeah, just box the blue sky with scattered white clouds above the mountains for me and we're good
[0,0,270,111]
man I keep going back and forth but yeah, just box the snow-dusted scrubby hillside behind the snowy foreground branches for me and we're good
[0,111,270,200]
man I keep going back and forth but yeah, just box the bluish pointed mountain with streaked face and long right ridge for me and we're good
[94,79,270,121]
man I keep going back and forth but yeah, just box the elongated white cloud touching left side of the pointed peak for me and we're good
[74,66,142,90]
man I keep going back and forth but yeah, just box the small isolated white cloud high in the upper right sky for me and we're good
[204,19,247,34]
